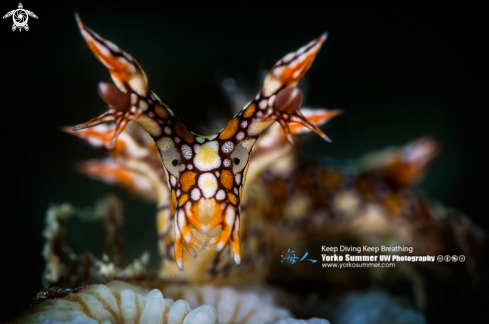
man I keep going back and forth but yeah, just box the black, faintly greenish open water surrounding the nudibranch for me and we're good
[0,1,489,321]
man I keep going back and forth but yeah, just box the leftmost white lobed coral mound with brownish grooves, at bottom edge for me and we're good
[14,281,217,324]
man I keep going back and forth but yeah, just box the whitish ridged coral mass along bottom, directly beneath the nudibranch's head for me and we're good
[12,280,329,324]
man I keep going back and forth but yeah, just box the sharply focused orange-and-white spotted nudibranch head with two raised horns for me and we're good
[73,18,329,270]
